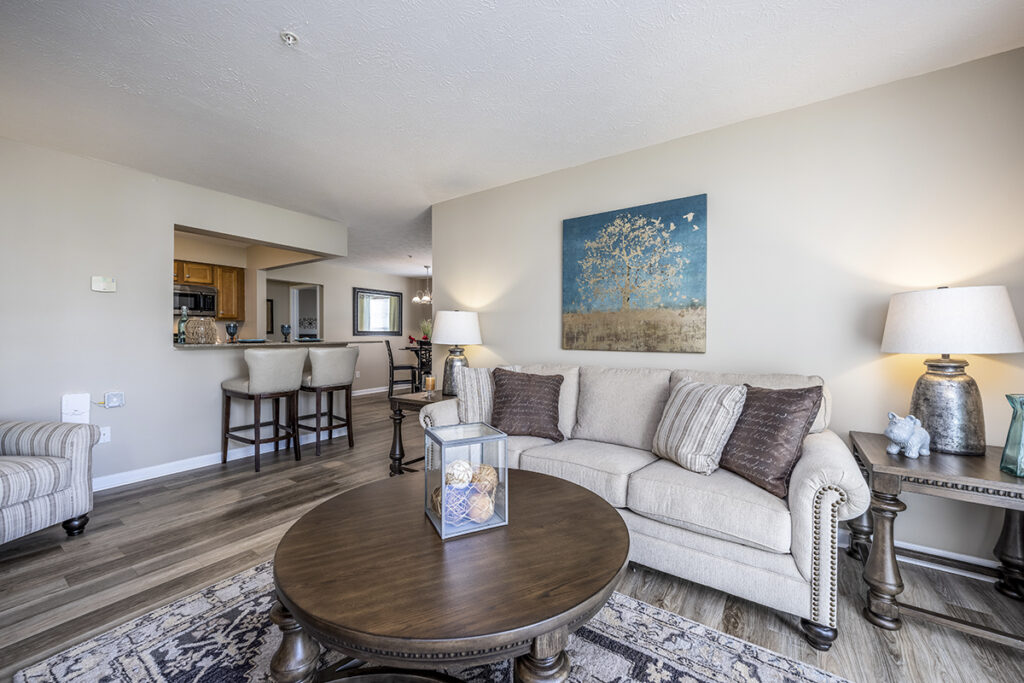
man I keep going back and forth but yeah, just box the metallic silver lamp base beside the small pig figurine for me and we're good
[910,355,985,456]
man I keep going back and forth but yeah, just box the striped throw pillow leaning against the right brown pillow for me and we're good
[652,382,746,474]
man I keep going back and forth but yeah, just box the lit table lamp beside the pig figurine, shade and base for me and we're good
[882,286,1024,456]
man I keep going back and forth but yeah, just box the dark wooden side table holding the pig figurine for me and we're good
[848,432,1024,649]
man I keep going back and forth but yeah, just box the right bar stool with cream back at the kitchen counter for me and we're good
[298,346,359,456]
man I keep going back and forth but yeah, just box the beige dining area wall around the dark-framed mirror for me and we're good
[270,259,431,390]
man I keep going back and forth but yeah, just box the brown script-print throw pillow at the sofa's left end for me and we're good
[490,368,565,441]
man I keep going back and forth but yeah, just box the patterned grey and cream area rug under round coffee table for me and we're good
[14,562,845,683]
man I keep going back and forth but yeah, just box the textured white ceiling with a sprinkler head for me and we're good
[0,0,1024,275]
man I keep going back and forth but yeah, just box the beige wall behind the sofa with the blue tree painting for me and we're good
[433,50,1024,556]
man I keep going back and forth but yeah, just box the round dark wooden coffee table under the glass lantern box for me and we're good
[271,470,630,683]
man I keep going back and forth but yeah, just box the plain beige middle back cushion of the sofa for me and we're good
[572,368,672,451]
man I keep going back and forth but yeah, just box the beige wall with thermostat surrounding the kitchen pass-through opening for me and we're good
[0,139,346,475]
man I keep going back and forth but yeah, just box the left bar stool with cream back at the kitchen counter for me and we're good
[220,348,306,472]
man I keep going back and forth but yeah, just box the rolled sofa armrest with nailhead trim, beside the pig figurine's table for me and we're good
[788,430,871,628]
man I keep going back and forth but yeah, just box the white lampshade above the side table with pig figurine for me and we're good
[882,285,1024,354]
